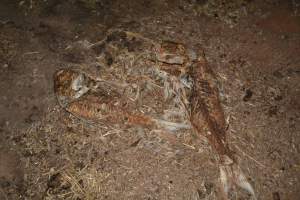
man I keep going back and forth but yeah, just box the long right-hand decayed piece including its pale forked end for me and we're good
[190,57,256,199]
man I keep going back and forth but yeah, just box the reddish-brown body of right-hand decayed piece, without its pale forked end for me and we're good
[190,58,233,159]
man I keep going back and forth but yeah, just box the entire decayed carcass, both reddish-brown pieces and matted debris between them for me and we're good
[54,30,256,199]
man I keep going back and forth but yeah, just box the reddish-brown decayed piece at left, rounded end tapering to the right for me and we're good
[54,69,158,126]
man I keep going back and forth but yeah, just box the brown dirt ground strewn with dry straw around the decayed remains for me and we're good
[0,0,300,200]
